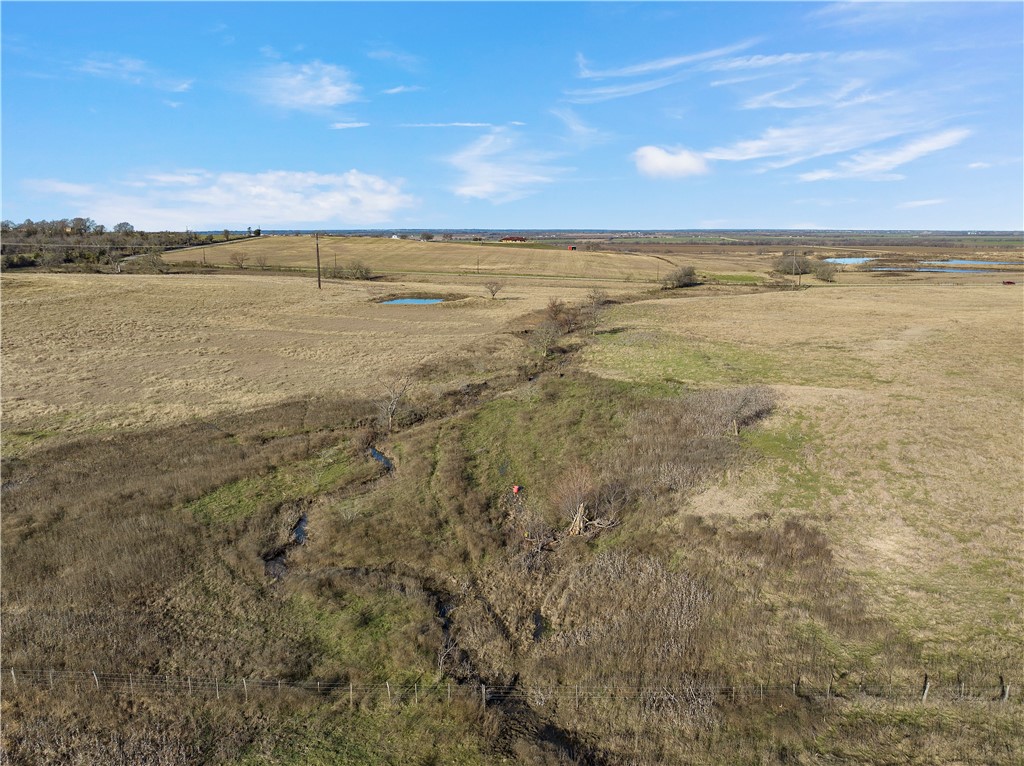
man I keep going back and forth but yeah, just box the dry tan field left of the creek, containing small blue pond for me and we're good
[2,274,606,451]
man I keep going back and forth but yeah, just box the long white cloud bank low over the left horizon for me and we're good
[31,170,416,230]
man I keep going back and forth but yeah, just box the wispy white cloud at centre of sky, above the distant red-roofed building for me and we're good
[447,128,566,203]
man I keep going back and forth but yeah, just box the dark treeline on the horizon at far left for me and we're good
[0,218,260,268]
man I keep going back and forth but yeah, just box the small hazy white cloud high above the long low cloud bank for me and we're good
[255,60,361,112]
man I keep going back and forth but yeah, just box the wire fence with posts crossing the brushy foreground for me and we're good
[0,668,1018,710]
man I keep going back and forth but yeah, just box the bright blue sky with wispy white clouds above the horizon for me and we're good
[0,2,1024,230]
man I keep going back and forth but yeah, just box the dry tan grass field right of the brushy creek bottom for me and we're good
[586,286,1024,670]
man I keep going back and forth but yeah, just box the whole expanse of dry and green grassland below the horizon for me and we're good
[0,238,1024,765]
